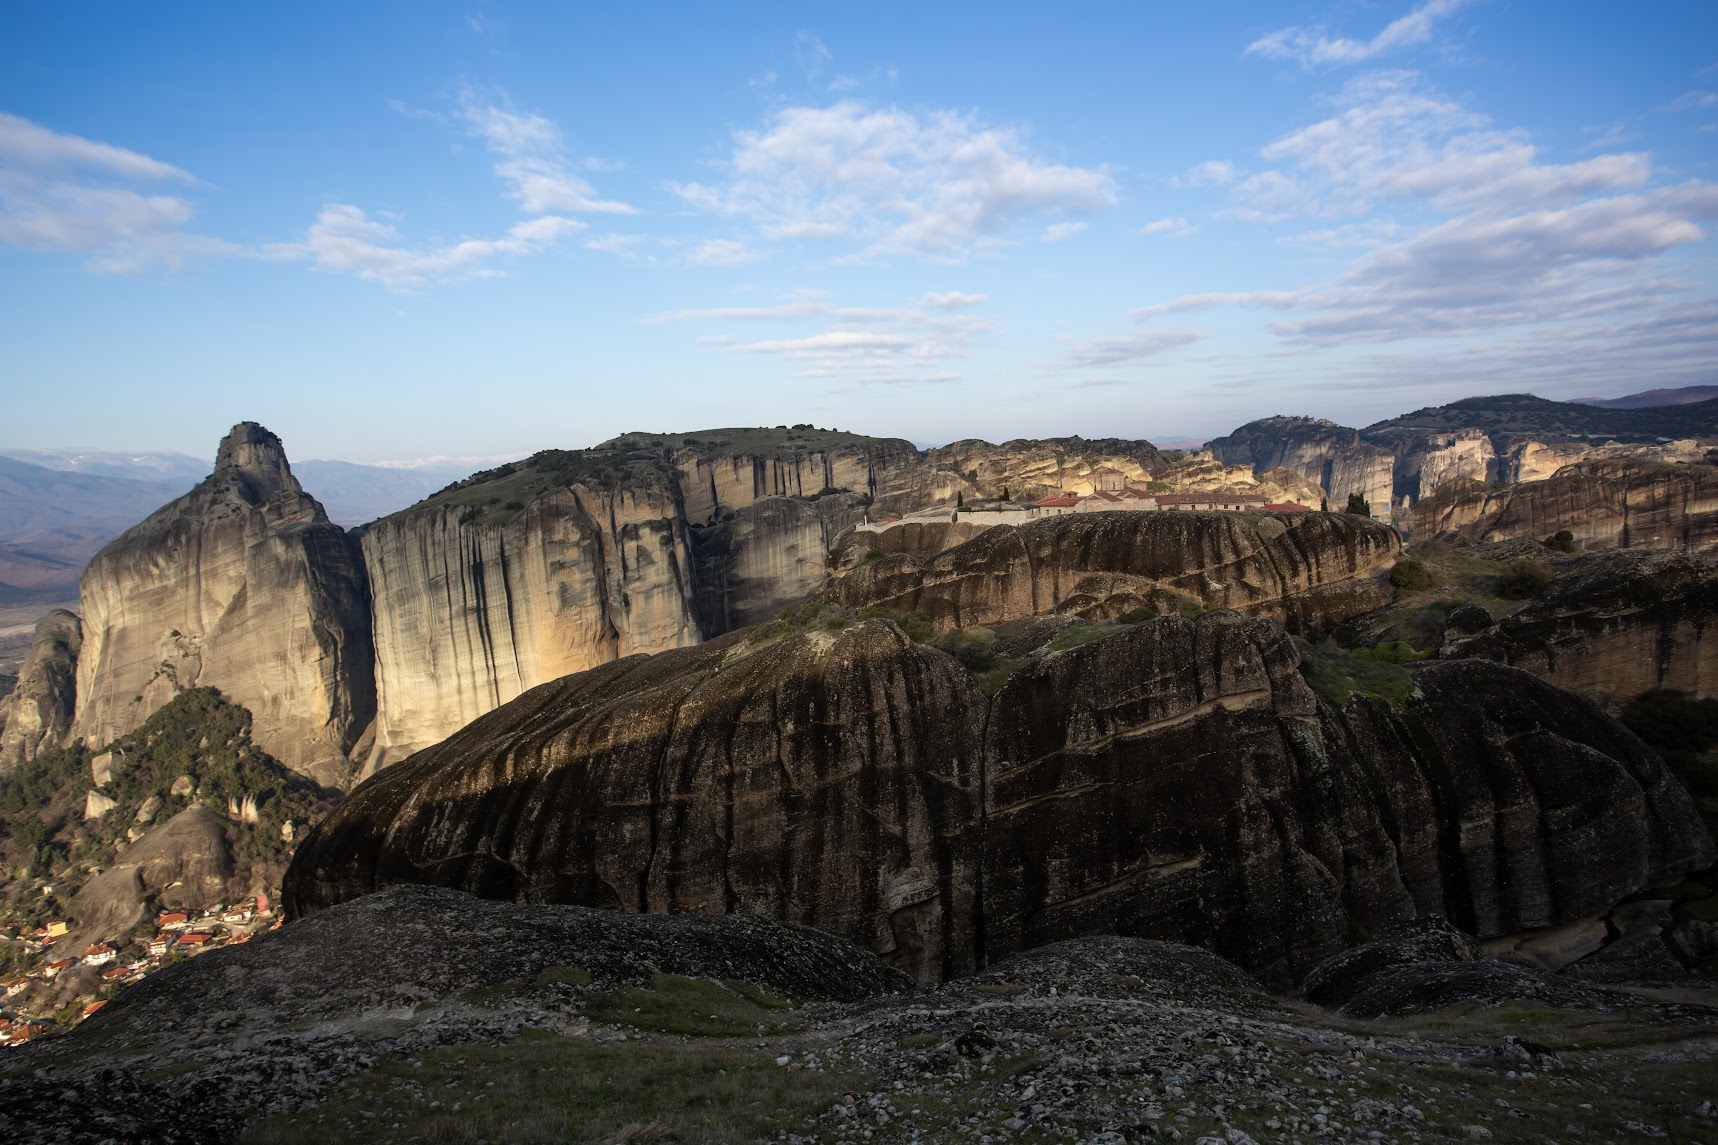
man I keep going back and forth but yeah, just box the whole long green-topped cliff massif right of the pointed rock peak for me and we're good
[362,426,953,774]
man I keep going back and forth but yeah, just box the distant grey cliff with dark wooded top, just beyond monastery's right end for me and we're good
[1204,418,1395,517]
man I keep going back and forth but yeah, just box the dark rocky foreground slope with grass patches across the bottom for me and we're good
[0,887,1718,1143]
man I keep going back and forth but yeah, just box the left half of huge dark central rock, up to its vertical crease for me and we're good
[292,622,984,977]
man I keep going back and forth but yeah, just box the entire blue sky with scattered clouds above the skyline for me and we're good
[0,0,1718,461]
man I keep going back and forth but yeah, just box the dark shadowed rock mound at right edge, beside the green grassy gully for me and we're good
[1440,550,1718,713]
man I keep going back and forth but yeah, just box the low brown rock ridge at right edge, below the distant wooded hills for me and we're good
[1414,461,1718,552]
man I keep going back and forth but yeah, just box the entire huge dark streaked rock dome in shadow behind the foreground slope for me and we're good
[285,614,1711,987]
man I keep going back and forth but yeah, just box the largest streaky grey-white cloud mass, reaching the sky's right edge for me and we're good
[1072,72,1718,380]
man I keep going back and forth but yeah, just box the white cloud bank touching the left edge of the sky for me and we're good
[0,112,242,273]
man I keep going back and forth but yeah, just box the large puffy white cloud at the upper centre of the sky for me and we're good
[673,100,1117,261]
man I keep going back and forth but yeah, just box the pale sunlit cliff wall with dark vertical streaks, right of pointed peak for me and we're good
[362,485,701,770]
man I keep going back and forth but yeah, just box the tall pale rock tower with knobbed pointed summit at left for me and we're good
[72,421,375,782]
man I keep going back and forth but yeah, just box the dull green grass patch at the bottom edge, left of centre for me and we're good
[241,1032,864,1145]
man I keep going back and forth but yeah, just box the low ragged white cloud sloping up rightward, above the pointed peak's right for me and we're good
[302,203,584,291]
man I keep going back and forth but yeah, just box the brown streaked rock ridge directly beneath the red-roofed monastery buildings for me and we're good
[826,512,1402,631]
